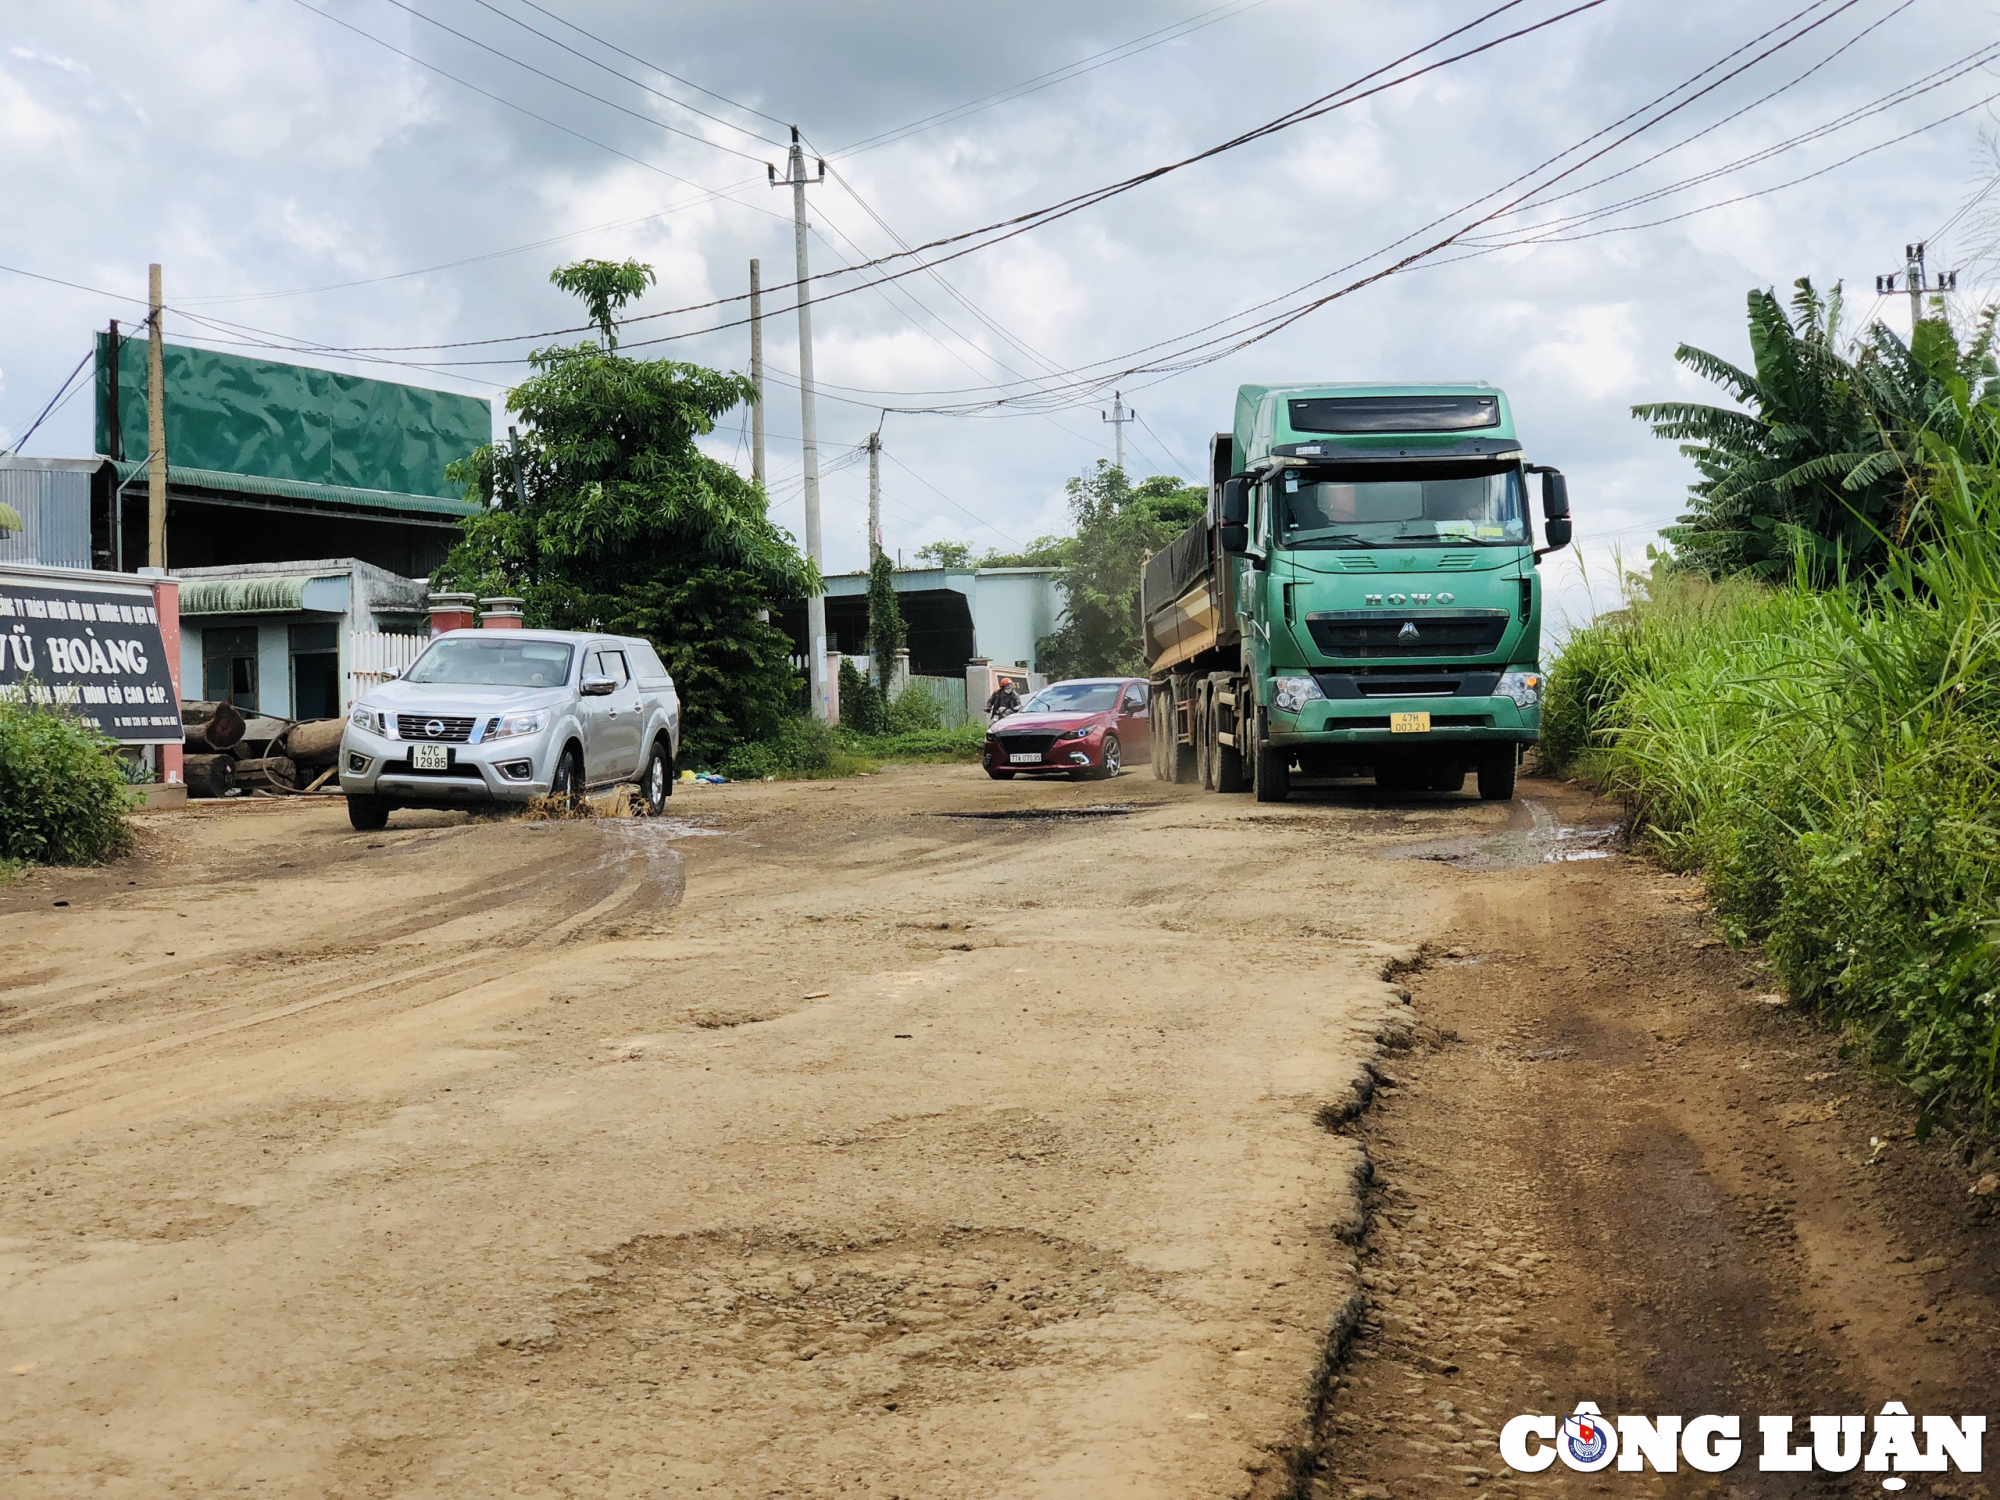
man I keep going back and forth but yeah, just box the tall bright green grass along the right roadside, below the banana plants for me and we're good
[1544,466,2000,1130]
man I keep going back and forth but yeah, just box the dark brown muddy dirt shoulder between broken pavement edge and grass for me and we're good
[1292,790,2000,1500]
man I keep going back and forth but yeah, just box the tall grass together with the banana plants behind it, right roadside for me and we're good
[1544,282,2000,1136]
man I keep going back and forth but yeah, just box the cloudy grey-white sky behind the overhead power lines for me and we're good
[0,0,2000,614]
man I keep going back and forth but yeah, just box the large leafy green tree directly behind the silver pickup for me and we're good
[438,262,820,764]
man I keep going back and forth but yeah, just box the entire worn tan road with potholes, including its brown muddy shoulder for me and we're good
[0,768,2000,1500]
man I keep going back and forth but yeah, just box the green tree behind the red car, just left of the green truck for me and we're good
[1038,460,1208,678]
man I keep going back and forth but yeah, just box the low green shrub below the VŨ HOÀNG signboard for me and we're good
[0,700,132,864]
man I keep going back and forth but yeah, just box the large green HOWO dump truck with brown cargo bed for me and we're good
[1140,384,1570,802]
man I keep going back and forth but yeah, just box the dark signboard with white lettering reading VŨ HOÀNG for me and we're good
[0,574,182,744]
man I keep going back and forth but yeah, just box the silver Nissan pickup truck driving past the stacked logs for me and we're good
[340,630,680,832]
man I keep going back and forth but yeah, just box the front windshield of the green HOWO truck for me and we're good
[1272,464,1528,546]
